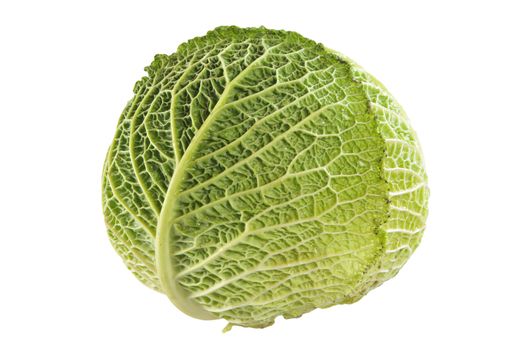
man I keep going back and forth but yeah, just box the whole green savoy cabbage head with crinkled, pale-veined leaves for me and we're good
[103,27,428,327]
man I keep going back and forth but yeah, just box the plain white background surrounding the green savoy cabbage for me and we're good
[0,0,527,350]
